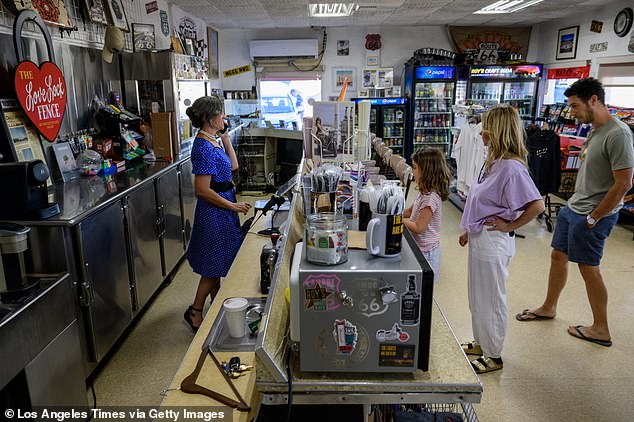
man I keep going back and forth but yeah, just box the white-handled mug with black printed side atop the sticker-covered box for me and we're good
[365,213,403,257]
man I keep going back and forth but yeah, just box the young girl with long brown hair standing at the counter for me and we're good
[403,148,451,282]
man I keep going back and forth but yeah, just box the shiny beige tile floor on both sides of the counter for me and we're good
[91,193,634,422]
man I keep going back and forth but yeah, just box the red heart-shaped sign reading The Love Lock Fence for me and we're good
[15,61,66,142]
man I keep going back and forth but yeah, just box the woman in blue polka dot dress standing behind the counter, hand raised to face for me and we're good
[184,96,251,332]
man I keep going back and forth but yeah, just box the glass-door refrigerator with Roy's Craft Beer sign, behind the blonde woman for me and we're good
[470,64,542,117]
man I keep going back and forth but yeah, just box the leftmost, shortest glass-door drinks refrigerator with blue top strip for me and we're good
[353,97,408,157]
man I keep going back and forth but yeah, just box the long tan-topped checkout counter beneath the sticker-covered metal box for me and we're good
[161,169,482,421]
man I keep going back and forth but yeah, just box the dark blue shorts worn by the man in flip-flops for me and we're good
[550,207,619,267]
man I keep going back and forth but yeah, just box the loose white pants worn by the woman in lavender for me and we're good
[468,227,515,358]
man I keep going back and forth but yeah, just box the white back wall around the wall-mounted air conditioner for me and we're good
[218,26,453,99]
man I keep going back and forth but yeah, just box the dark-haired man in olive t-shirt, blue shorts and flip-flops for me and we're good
[515,78,634,347]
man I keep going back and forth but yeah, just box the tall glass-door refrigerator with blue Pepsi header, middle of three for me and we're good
[404,66,456,157]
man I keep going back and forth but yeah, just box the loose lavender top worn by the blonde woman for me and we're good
[460,159,541,233]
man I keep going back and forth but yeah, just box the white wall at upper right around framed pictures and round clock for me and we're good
[528,1,634,71]
